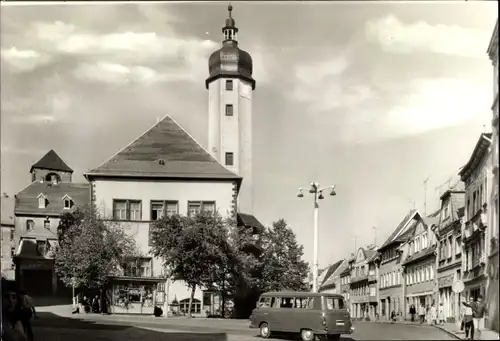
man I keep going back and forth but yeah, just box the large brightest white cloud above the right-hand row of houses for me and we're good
[338,78,489,143]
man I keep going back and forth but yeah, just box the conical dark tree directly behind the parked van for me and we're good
[260,219,309,292]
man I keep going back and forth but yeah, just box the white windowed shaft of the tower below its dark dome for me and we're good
[207,77,253,214]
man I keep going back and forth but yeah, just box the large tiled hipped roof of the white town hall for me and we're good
[84,116,241,179]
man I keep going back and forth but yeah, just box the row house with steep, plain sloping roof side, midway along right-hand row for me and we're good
[377,210,419,320]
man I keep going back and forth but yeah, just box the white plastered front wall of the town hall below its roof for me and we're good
[91,179,235,314]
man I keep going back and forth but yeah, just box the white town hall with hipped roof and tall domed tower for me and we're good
[84,6,263,314]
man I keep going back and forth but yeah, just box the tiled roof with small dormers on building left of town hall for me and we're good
[15,181,90,216]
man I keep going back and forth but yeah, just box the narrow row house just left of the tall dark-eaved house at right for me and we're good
[433,187,465,322]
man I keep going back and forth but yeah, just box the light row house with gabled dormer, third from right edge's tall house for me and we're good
[401,211,439,318]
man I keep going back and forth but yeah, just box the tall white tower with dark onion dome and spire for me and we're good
[205,5,255,214]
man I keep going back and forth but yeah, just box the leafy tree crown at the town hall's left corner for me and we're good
[55,210,139,288]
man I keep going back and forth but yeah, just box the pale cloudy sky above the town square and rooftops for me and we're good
[0,1,498,267]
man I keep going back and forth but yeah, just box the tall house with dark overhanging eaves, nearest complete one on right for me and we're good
[459,133,491,298]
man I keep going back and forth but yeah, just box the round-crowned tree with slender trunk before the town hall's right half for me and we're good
[151,212,229,314]
